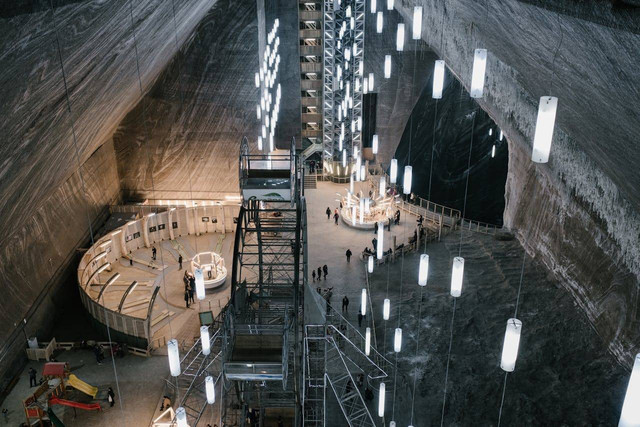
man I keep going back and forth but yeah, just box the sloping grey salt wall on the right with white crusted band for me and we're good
[396,0,640,366]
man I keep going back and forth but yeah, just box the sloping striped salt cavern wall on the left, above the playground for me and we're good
[0,0,215,389]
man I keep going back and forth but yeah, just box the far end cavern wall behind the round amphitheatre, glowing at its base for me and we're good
[114,0,300,200]
